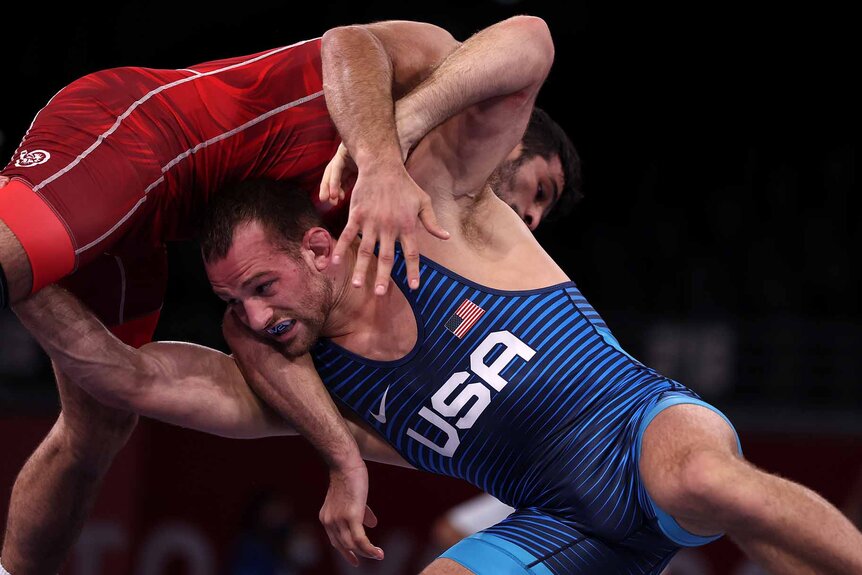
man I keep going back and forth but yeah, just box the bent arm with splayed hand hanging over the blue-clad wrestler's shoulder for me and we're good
[321,22,458,295]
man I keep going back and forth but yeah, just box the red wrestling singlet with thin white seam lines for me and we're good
[0,39,340,345]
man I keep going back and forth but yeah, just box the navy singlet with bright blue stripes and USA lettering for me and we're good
[312,250,744,575]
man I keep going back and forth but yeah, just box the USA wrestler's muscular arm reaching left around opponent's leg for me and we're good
[14,285,409,467]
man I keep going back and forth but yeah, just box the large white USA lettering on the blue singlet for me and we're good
[407,331,536,457]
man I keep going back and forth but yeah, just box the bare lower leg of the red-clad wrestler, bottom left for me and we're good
[0,370,137,575]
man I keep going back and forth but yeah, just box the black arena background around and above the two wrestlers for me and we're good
[0,0,862,572]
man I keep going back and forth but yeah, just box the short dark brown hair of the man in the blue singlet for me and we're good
[200,180,321,261]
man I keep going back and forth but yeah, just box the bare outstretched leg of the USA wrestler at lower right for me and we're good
[640,405,862,575]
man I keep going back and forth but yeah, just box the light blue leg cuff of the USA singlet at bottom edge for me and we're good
[440,533,554,575]
